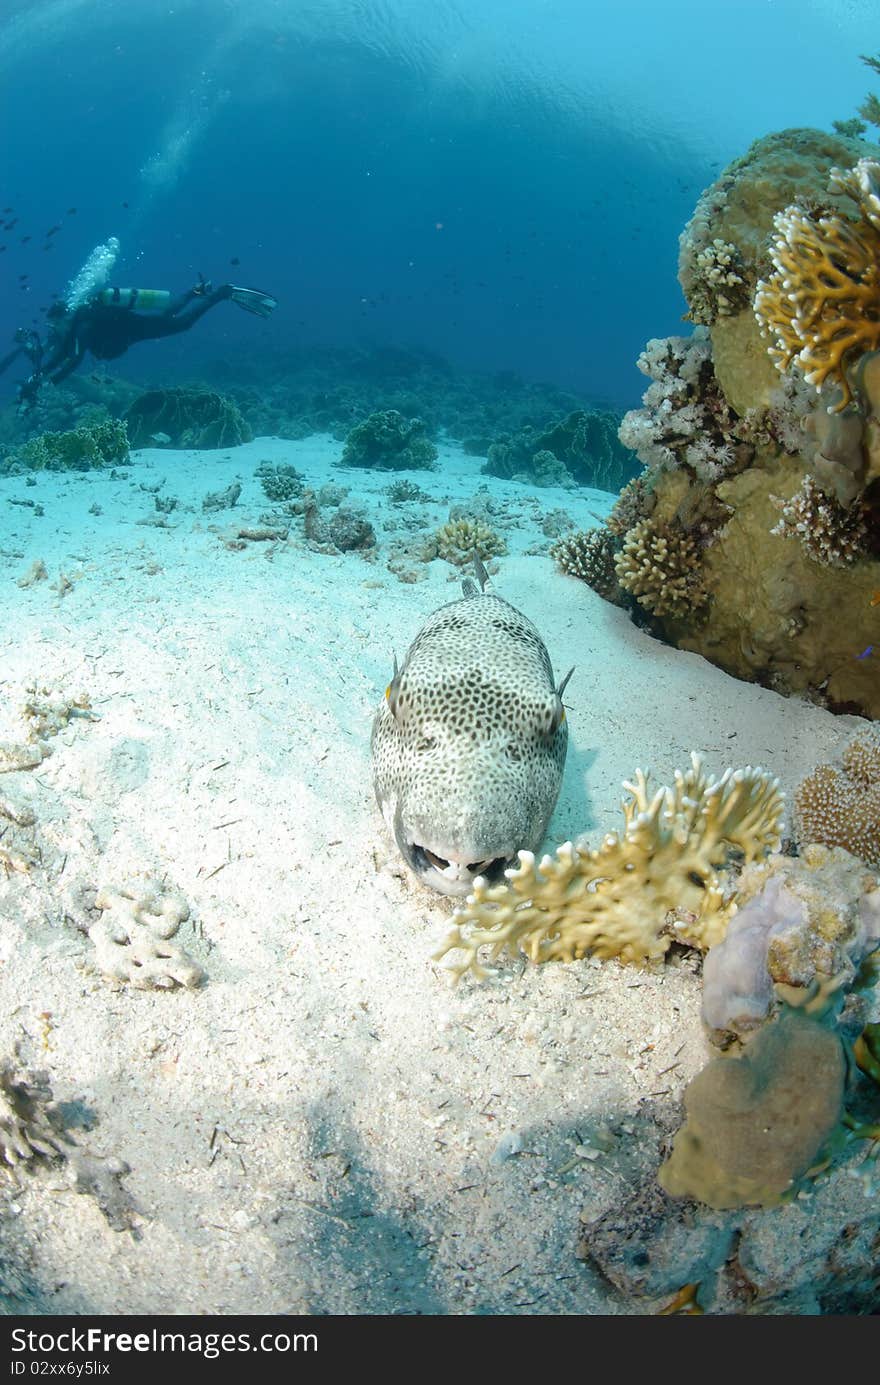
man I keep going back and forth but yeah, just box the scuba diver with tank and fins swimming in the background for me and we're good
[15,274,277,410]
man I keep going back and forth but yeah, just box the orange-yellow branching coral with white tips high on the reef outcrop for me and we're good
[754,159,880,413]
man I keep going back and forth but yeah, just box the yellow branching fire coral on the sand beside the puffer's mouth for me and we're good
[435,753,783,981]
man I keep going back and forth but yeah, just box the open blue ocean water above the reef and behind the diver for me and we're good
[0,0,876,407]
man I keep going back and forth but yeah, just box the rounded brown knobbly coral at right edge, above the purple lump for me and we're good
[794,726,880,868]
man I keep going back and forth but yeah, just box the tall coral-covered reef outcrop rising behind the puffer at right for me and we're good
[587,130,880,717]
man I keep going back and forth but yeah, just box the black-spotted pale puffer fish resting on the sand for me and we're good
[371,560,574,895]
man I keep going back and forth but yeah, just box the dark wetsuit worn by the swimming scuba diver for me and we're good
[40,284,233,385]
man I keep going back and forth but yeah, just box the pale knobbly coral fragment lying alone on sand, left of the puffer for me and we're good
[89,878,205,990]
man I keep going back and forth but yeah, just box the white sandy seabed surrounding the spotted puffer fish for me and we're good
[0,438,870,1314]
